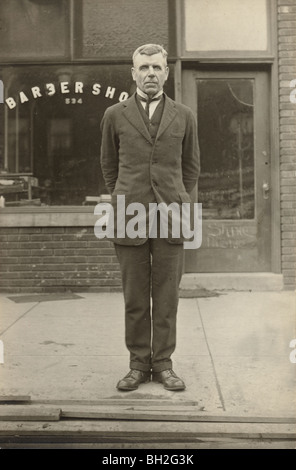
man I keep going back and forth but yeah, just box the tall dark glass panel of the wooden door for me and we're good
[197,79,255,219]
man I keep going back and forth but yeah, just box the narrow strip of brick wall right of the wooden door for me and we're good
[278,0,296,289]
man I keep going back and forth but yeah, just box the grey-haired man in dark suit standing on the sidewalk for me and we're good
[101,44,199,391]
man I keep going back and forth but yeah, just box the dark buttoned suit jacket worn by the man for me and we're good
[101,94,200,245]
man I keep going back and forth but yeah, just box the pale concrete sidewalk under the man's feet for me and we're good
[0,292,296,417]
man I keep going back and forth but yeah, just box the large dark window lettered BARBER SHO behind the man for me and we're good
[0,65,174,206]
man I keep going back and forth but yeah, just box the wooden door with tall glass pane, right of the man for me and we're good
[182,70,271,272]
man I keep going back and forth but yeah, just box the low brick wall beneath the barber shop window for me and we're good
[0,227,121,293]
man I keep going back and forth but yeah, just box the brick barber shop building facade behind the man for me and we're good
[0,0,296,293]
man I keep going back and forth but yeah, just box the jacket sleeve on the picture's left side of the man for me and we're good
[100,109,119,194]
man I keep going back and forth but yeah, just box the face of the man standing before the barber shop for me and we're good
[132,52,169,97]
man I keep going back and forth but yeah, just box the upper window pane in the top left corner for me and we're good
[0,0,70,60]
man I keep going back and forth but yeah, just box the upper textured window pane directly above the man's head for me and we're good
[76,0,174,58]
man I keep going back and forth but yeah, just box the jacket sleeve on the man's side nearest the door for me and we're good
[182,109,200,193]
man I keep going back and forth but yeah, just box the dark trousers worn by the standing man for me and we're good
[115,238,184,372]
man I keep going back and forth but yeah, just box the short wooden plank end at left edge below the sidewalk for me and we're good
[0,405,61,421]
